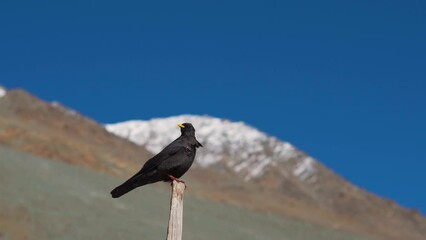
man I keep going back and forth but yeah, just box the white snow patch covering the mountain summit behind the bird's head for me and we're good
[105,115,315,180]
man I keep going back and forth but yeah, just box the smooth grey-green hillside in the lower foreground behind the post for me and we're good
[0,147,369,240]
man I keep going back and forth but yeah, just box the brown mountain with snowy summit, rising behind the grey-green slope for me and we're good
[0,90,426,240]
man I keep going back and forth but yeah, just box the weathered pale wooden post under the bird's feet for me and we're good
[167,181,185,240]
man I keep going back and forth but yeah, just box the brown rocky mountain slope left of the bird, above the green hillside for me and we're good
[0,89,150,174]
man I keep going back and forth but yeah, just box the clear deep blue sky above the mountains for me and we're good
[0,0,426,213]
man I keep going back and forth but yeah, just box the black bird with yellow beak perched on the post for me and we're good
[111,123,203,198]
